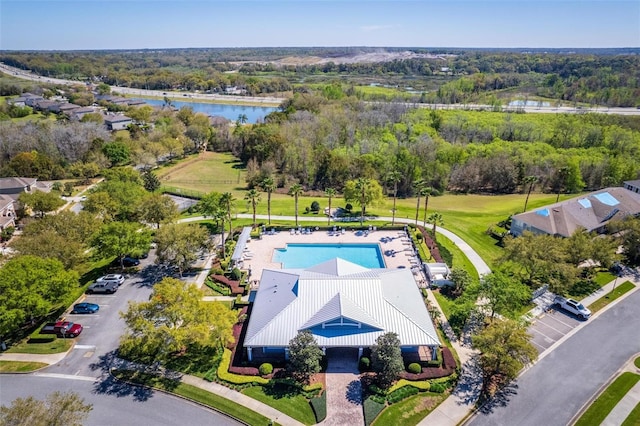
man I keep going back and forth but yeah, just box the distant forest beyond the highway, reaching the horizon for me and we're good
[0,47,640,107]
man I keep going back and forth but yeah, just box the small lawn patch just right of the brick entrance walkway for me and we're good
[372,392,447,426]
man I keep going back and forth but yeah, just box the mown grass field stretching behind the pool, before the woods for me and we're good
[157,152,570,267]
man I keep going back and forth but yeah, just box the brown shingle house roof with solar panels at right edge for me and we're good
[513,187,640,237]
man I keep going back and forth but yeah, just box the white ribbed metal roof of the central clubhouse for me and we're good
[244,258,440,347]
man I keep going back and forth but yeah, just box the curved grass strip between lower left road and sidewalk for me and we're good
[112,370,270,425]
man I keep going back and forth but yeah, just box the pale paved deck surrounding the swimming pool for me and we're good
[241,230,426,287]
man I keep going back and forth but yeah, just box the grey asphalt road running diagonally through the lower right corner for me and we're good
[467,291,640,426]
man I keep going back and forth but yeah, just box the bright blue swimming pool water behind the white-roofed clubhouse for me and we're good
[273,244,385,269]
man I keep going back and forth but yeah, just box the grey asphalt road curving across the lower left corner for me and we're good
[0,374,239,426]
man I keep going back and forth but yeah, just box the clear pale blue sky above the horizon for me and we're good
[0,0,640,50]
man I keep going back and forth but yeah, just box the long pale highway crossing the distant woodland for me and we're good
[0,63,640,115]
